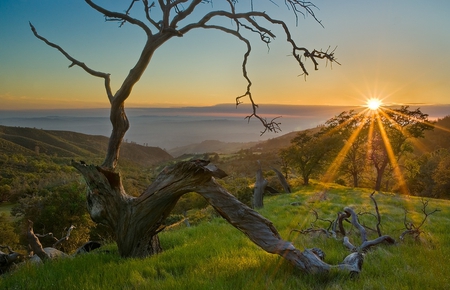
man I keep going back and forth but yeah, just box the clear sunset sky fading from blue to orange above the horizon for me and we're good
[0,0,450,113]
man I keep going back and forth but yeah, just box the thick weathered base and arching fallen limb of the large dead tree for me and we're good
[72,160,359,273]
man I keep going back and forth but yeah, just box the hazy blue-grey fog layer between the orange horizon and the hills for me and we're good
[0,104,450,150]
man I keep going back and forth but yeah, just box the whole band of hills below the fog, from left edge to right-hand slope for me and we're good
[0,125,306,166]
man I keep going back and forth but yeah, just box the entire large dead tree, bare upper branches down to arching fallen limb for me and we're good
[30,0,359,273]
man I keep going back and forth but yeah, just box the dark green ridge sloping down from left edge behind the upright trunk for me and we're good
[0,126,172,166]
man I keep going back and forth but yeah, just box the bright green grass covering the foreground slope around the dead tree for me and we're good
[0,187,450,290]
